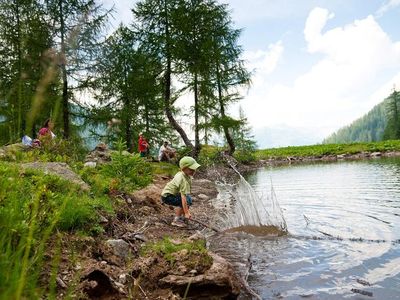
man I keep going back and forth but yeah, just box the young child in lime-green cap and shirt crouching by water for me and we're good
[161,156,200,227]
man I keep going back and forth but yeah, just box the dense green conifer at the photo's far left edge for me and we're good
[0,0,58,142]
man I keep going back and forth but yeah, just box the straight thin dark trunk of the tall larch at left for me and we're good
[58,0,70,139]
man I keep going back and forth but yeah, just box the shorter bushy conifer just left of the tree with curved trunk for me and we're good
[92,26,168,151]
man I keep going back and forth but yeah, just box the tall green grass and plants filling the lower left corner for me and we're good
[0,163,112,299]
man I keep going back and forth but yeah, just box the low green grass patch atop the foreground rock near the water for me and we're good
[141,237,212,265]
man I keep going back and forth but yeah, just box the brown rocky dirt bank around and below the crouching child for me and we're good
[50,173,250,299]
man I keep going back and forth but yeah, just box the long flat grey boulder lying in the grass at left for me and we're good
[21,162,90,191]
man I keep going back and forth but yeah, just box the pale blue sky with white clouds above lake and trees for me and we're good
[103,0,400,148]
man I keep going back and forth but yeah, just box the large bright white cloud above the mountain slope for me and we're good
[243,8,400,138]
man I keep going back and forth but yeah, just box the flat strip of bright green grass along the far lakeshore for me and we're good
[256,140,400,160]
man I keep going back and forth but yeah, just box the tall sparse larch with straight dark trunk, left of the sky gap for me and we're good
[46,0,110,138]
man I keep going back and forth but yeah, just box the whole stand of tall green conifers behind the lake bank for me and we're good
[0,0,255,156]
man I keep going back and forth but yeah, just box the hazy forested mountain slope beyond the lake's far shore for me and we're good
[322,99,388,144]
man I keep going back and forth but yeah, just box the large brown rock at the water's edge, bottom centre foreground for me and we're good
[159,252,240,299]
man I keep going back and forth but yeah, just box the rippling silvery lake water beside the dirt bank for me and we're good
[211,158,400,299]
